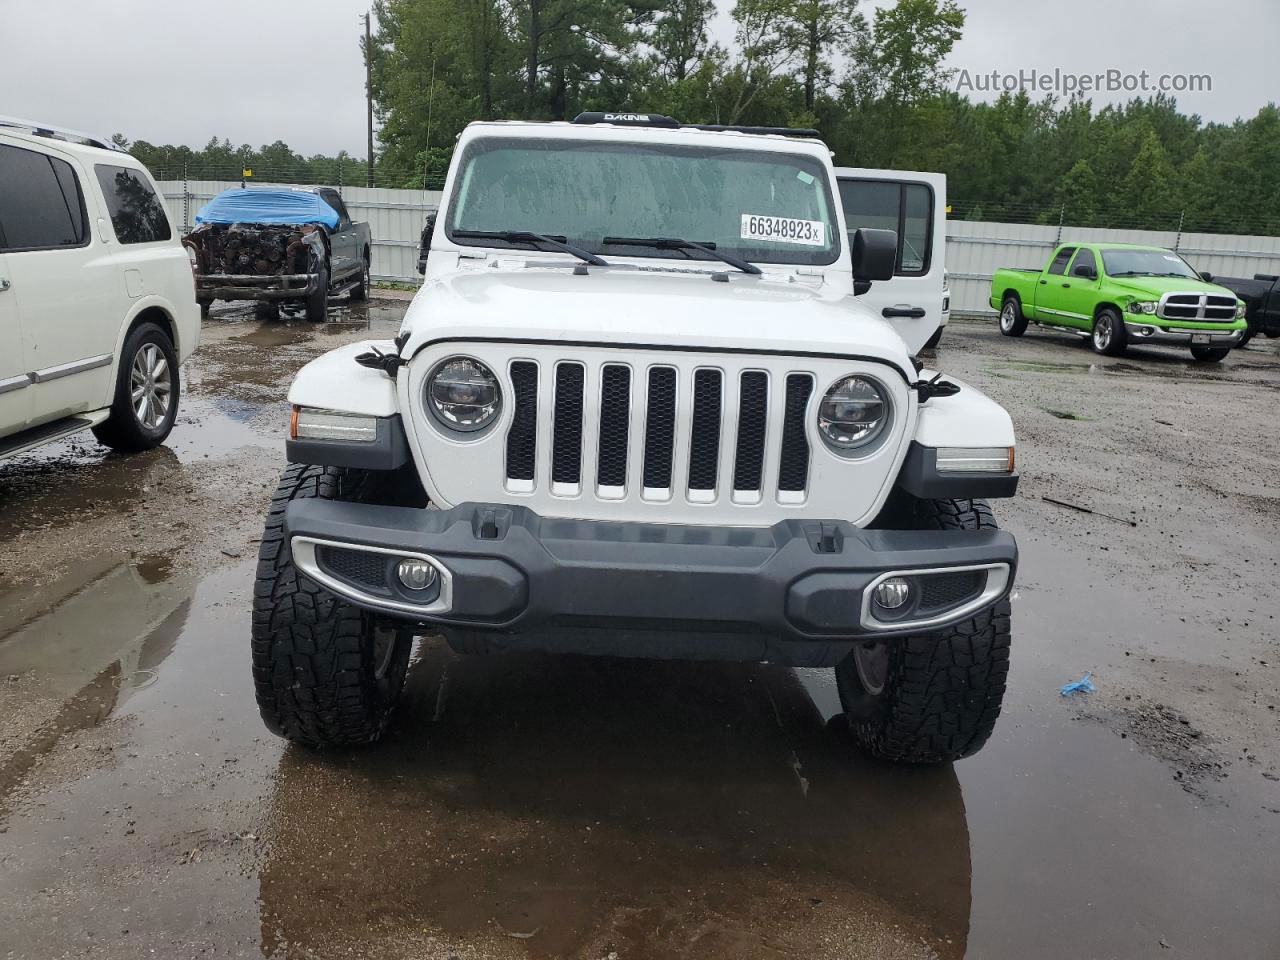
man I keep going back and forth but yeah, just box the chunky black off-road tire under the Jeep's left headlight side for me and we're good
[252,463,413,748]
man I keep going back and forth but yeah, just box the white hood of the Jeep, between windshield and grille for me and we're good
[402,264,914,378]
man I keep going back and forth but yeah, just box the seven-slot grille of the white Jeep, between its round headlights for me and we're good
[506,361,814,503]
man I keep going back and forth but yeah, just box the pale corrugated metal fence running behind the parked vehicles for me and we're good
[160,180,1280,315]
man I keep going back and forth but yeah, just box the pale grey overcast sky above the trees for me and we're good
[0,0,1280,156]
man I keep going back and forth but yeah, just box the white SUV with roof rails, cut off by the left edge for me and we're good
[0,118,200,458]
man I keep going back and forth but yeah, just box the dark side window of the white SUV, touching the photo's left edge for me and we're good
[0,146,88,251]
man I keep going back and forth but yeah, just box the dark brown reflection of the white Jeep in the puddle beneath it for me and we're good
[261,644,969,957]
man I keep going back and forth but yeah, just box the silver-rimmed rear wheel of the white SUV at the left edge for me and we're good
[93,324,180,452]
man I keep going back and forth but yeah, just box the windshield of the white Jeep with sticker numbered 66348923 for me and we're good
[445,137,840,265]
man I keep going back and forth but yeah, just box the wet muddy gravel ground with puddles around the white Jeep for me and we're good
[0,302,1280,960]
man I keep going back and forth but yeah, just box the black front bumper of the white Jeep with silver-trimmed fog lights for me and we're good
[285,500,1018,641]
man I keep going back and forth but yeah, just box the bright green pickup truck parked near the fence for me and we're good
[991,243,1248,361]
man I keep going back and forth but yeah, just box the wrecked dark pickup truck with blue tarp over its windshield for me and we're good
[182,187,371,323]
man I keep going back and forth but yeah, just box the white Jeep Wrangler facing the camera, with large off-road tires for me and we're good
[253,114,1018,762]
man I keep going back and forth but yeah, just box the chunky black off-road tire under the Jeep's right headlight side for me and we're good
[836,500,1010,763]
